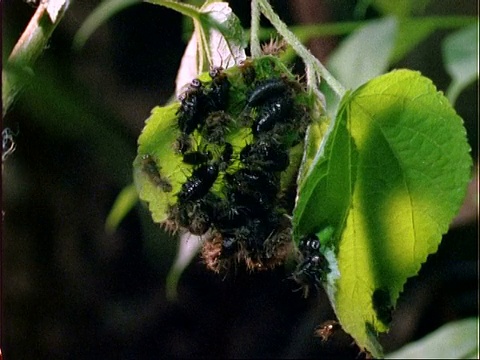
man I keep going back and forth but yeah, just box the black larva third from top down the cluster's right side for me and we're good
[240,139,290,171]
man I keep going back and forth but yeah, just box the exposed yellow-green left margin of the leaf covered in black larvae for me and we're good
[133,103,186,222]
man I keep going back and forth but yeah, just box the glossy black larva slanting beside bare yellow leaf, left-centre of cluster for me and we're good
[177,164,218,203]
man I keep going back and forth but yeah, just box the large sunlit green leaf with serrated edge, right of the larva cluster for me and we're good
[294,70,471,357]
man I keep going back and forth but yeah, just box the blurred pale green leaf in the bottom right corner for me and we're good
[385,317,479,359]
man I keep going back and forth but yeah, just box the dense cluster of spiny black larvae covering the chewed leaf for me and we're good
[163,60,316,271]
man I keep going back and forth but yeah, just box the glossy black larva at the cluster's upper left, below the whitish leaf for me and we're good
[177,79,208,134]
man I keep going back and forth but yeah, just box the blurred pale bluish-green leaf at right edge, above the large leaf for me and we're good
[442,24,478,103]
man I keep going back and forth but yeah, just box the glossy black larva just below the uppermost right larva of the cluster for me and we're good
[252,96,293,135]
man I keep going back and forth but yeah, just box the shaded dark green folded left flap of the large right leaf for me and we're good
[293,93,356,245]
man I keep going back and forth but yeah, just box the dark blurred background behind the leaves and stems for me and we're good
[1,0,478,359]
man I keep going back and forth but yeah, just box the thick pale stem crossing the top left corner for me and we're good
[2,1,68,116]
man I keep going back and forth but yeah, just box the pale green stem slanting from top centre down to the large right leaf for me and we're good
[258,0,345,98]
